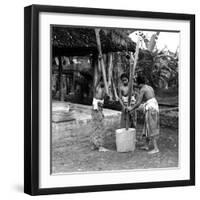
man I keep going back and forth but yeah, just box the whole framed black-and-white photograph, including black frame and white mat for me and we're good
[24,5,195,195]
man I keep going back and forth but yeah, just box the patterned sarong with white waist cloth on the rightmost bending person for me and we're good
[144,98,160,137]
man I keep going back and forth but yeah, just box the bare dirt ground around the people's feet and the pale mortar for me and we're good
[52,124,178,173]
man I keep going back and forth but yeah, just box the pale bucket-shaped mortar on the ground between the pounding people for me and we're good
[115,128,136,152]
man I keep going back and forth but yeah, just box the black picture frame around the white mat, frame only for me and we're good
[24,5,195,195]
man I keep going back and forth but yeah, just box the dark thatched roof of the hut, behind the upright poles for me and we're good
[51,26,136,56]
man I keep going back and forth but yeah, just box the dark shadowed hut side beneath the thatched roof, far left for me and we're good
[52,56,93,101]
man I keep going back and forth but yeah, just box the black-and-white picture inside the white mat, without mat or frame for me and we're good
[50,24,180,175]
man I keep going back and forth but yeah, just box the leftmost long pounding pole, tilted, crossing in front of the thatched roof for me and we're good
[95,28,109,95]
